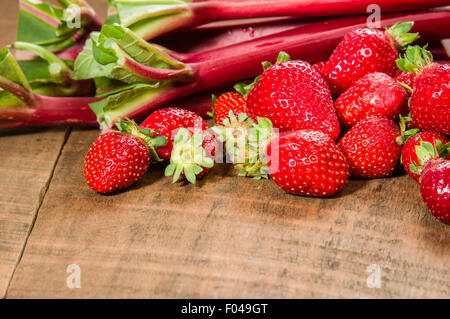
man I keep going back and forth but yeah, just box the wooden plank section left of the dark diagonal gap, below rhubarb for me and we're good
[0,128,67,297]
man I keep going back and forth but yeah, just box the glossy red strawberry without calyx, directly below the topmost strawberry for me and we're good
[334,73,408,127]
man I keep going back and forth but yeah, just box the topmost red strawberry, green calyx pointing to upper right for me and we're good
[323,22,418,96]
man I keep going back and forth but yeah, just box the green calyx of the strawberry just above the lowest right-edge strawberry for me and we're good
[409,139,450,182]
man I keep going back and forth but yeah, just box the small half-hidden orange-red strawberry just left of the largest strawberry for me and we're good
[213,92,247,125]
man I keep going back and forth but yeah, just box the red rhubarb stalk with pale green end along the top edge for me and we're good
[107,0,448,40]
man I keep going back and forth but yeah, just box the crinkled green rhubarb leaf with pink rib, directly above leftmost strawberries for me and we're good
[72,25,192,87]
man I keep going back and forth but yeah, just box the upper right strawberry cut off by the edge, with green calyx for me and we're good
[397,46,450,135]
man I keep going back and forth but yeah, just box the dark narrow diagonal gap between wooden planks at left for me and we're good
[2,127,72,299]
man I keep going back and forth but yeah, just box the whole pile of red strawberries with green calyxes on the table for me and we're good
[85,23,450,223]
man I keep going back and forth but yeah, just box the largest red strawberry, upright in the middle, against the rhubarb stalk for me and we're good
[247,53,339,139]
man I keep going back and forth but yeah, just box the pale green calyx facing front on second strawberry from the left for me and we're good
[164,128,214,184]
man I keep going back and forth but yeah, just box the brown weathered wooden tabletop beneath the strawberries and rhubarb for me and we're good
[0,0,450,298]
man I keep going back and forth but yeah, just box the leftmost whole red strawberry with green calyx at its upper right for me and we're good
[84,120,167,194]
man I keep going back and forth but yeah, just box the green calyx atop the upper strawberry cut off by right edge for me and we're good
[396,45,433,76]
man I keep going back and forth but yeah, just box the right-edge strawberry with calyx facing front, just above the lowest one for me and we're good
[401,132,450,183]
